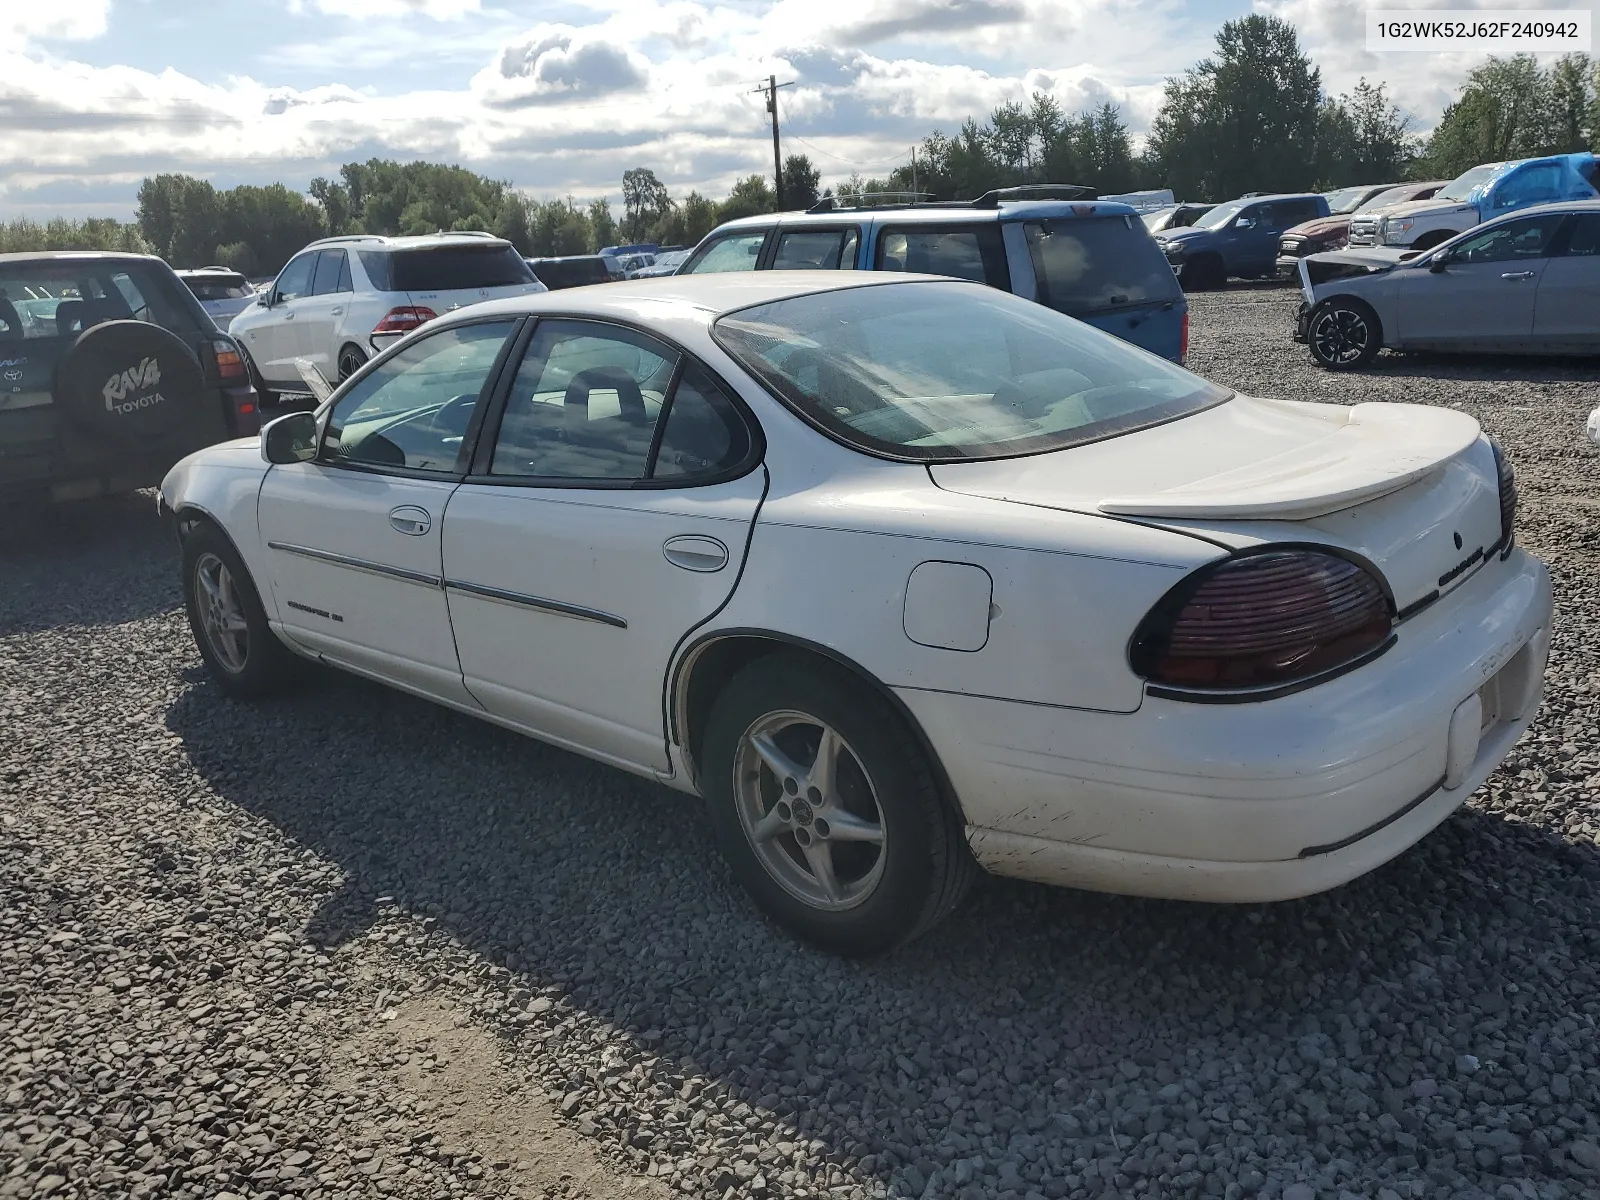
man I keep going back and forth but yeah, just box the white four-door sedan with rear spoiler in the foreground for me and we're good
[162,272,1550,954]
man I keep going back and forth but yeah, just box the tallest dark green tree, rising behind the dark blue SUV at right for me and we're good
[1149,14,1323,200]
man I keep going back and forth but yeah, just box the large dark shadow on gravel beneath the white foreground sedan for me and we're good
[168,662,1600,1195]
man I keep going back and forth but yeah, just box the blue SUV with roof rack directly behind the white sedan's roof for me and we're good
[677,184,1189,363]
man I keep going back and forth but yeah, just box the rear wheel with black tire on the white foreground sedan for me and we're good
[701,653,978,955]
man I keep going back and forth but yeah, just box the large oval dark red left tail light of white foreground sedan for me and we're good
[1128,549,1394,699]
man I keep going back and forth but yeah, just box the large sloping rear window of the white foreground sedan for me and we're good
[712,282,1232,461]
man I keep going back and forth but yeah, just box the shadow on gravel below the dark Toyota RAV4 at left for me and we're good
[0,491,182,637]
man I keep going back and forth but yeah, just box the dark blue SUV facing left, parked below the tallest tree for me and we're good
[1157,192,1328,291]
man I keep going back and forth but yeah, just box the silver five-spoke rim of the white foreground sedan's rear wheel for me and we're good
[733,712,888,912]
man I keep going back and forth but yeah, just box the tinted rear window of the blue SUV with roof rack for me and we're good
[1022,216,1182,317]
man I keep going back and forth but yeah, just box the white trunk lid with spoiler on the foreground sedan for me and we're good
[930,397,1501,610]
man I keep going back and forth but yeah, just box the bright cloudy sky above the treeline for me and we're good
[0,0,1580,218]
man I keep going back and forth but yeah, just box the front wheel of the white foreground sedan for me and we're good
[184,522,299,698]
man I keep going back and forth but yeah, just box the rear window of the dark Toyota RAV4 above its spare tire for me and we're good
[0,259,196,344]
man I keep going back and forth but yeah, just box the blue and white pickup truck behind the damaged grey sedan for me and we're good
[1350,150,1597,251]
